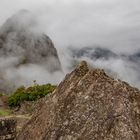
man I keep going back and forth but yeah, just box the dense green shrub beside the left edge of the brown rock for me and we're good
[8,84,56,107]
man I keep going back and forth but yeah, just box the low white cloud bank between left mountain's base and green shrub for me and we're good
[5,64,63,87]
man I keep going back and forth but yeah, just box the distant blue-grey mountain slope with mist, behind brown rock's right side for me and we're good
[69,46,140,88]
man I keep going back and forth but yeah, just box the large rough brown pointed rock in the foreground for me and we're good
[18,62,140,140]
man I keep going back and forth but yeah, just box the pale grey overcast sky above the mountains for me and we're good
[0,0,140,53]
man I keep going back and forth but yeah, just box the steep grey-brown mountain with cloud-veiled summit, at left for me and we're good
[0,10,61,72]
